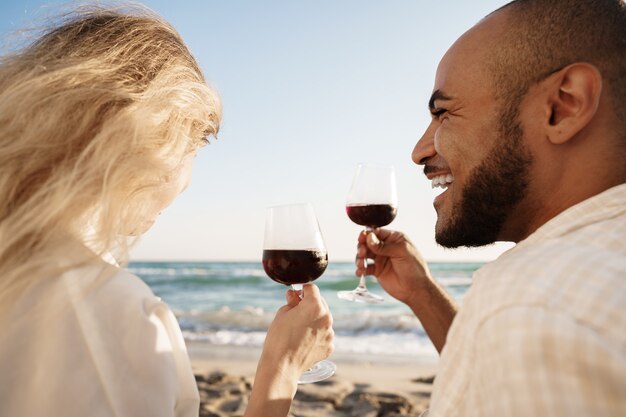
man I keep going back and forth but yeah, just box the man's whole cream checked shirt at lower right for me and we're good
[428,184,626,417]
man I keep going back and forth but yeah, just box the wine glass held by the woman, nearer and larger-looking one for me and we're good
[263,203,337,384]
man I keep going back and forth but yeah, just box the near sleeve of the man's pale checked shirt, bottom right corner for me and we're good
[467,306,626,417]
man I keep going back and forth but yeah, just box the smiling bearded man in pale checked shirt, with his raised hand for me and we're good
[356,0,626,417]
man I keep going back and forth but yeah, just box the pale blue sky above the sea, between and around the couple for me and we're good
[0,0,512,262]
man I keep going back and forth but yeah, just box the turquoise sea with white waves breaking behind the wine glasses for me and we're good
[129,262,482,359]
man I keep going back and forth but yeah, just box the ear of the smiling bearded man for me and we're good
[545,63,602,145]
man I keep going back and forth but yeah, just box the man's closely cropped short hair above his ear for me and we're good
[489,0,626,135]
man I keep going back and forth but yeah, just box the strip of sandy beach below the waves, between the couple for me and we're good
[187,342,437,417]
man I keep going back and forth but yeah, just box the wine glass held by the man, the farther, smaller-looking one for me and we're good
[337,164,398,304]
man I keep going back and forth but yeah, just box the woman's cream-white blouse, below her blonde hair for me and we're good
[0,247,199,417]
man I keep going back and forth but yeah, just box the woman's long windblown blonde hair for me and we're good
[0,7,221,305]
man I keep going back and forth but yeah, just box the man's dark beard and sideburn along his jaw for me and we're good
[435,106,532,248]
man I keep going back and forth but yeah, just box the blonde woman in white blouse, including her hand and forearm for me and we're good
[0,6,333,417]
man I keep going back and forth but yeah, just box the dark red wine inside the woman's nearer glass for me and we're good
[263,249,328,285]
